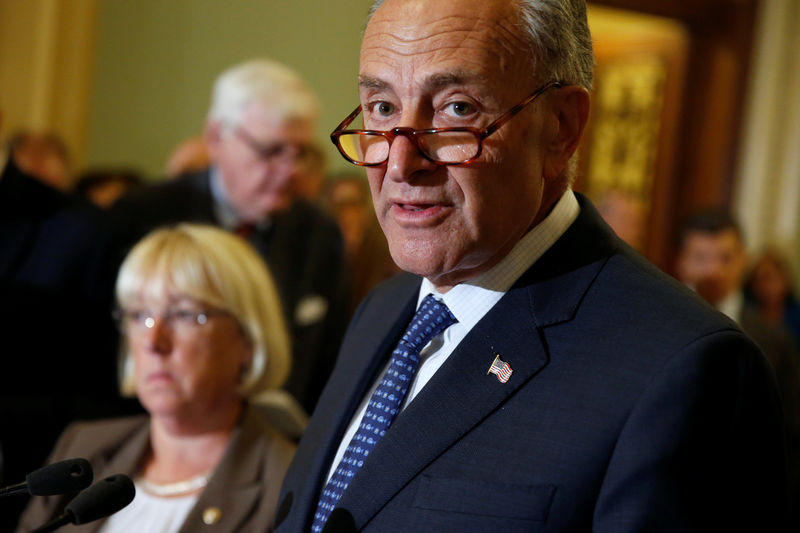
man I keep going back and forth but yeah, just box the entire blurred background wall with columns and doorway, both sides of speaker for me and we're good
[0,0,800,281]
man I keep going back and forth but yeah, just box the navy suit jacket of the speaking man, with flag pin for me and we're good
[276,193,786,533]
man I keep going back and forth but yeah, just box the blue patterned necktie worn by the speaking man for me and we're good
[311,294,457,533]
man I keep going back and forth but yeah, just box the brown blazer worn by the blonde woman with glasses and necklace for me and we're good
[17,406,294,533]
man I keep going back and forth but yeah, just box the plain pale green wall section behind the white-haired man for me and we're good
[87,0,371,178]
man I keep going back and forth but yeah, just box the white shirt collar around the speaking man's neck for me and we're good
[417,189,580,328]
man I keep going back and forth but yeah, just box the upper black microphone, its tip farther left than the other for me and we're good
[0,458,94,496]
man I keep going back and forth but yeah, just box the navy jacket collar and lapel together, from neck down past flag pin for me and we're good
[337,197,613,528]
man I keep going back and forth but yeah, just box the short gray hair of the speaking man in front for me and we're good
[367,0,594,90]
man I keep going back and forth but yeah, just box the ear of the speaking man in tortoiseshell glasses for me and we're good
[544,85,589,180]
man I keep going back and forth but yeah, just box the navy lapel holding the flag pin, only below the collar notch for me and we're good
[339,282,548,527]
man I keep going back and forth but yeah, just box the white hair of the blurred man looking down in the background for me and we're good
[208,59,320,124]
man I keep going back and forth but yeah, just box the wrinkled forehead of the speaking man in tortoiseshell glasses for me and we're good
[359,0,532,95]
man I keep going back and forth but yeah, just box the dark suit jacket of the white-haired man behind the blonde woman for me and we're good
[111,171,347,413]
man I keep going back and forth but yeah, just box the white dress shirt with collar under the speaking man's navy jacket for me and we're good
[328,189,580,479]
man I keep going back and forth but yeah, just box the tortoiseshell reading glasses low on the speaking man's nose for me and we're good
[331,81,566,167]
